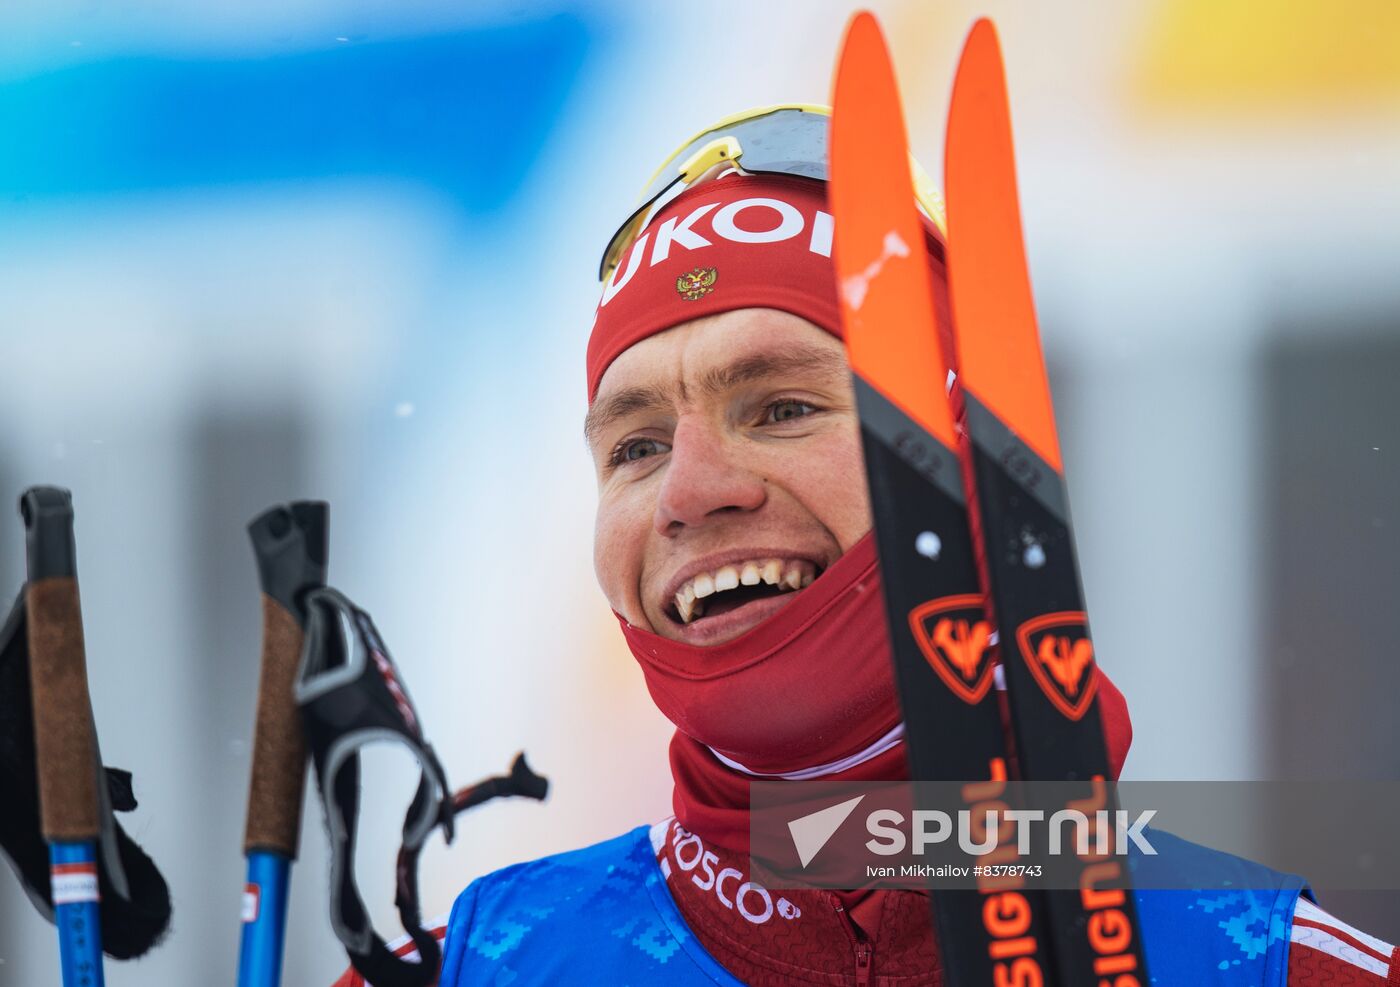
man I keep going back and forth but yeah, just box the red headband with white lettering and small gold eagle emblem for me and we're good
[588,175,949,403]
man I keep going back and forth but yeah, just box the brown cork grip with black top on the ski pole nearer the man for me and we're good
[244,501,328,858]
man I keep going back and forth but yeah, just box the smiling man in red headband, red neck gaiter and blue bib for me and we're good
[333,109,1396,987]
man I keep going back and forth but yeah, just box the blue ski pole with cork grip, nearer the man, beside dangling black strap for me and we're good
[238,501,328,987]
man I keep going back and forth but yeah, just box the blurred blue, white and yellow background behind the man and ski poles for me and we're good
[0,0,1400,987]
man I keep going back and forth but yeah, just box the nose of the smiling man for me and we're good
[654,419,767,536]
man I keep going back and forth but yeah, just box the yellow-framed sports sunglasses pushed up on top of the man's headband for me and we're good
[598,104,945,281]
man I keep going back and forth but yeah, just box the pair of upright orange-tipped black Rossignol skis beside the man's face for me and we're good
[830,13,1149,987]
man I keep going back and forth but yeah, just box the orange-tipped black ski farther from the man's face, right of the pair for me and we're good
[944,20,1149,987]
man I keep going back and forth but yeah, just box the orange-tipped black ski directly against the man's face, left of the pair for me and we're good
[830,13,1049,987]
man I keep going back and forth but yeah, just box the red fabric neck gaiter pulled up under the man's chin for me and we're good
[619,535,1133,853]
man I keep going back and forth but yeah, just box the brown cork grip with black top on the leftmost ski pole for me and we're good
[20,487,101,841]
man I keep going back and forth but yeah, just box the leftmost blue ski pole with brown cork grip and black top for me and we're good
[20,487,104,987]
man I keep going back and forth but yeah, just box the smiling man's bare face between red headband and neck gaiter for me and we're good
[585,308,871,645]
